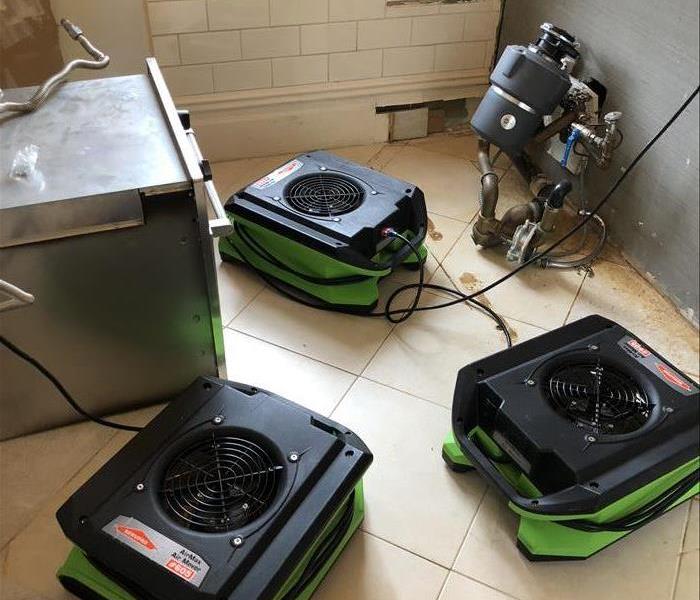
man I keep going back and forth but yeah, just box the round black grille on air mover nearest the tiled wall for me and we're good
[284,173,365,217]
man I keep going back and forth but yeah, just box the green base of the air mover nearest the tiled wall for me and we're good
[219,213,428,311]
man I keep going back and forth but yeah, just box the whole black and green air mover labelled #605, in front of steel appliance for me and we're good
[57,378,372,600]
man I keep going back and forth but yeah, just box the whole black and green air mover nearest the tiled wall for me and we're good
[219,152,428,311]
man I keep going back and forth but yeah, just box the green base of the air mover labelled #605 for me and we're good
[56,482,365,600]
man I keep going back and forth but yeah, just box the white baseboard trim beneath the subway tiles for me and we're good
[176,69,488,162]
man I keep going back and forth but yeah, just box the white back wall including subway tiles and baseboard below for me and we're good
[147,0,500,160]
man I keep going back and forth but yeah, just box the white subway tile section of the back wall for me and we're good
[146,0,500,96]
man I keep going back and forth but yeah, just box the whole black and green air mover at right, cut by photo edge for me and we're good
[443,316,699,560]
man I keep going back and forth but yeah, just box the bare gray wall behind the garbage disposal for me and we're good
[501,0,699,327]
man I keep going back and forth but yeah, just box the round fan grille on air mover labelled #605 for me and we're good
[161,433,283,533]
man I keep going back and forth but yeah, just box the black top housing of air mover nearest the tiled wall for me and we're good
[225,151,428,270]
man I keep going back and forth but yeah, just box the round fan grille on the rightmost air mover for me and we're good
[545,361,652,435]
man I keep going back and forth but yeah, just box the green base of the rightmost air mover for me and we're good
[442,428,700,561]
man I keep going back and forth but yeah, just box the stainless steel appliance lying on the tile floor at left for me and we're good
[0,59,230,439]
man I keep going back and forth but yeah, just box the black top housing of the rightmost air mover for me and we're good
[452,315,700,515]
